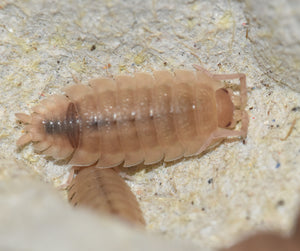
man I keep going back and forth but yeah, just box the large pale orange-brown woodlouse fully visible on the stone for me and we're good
[16,66,248,167]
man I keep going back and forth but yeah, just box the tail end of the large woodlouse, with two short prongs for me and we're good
[16,95,74,159]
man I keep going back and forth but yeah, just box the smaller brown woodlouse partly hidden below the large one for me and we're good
[68,166,145,225]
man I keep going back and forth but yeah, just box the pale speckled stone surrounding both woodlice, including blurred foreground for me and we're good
[0,0,300,250]
